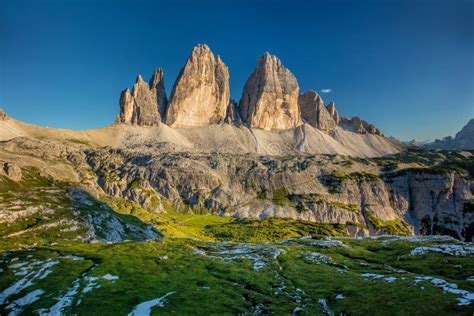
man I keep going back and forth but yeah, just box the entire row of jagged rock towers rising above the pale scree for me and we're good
[118,44,382,135]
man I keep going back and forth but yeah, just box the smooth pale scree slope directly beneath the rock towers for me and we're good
[0,116,403,157]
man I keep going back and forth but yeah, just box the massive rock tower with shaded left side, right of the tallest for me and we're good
[239,53,301,130]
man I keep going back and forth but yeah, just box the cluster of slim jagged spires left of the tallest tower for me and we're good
[118,68,167,126]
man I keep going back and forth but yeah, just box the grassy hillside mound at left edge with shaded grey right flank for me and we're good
[0,168,159,249]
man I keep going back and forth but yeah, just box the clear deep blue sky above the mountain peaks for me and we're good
[0,0,474,140]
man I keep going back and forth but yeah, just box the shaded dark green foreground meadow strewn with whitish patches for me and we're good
[0,238,474,315]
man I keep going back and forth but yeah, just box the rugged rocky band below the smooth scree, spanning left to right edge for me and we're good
[0,138,474,240]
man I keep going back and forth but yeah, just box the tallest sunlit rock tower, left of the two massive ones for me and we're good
[166,45,230,127]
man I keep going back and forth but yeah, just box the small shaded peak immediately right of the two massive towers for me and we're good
[298,91,336,131]
